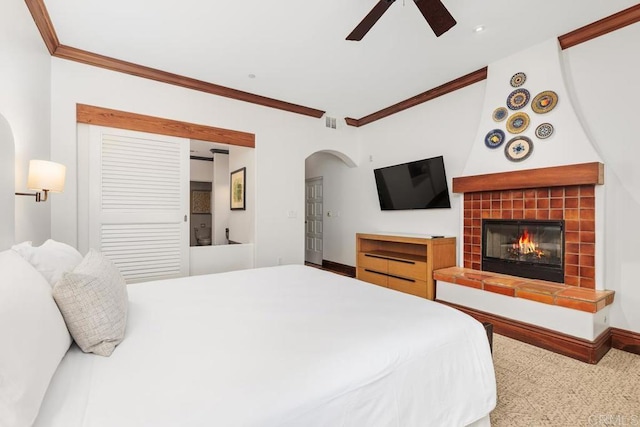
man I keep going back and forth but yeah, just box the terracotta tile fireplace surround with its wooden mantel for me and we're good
[441,162,613,311]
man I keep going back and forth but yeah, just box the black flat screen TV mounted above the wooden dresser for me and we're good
[373,156,451,211]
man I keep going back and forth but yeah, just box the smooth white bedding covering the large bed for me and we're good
[35,266,496,427]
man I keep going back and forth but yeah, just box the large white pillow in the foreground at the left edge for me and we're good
[0,250,71,426]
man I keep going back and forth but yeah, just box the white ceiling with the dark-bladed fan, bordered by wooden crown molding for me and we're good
[45,0,637,118]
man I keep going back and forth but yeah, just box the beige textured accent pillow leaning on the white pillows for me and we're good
[53,249,129,356]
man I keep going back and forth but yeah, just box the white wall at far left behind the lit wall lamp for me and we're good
[0,1,52,244]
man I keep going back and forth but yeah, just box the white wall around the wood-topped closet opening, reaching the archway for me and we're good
[50,57,358,266]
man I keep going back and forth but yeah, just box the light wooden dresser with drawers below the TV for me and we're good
[356,233,456,300]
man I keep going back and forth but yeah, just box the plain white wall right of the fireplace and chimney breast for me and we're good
[564,23,640,332]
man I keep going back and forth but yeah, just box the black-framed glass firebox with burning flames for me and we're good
[482,219,564,283]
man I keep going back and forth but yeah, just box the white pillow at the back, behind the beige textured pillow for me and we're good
[11,239,82,286]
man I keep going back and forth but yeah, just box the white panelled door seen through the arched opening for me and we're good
[304,177,323,265]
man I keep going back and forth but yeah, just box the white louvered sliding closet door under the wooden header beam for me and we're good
[89,126,189,283]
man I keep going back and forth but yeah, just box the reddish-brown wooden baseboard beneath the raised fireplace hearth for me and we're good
[436,300,612,364]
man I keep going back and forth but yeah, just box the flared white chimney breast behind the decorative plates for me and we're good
[462,38,602,176]
